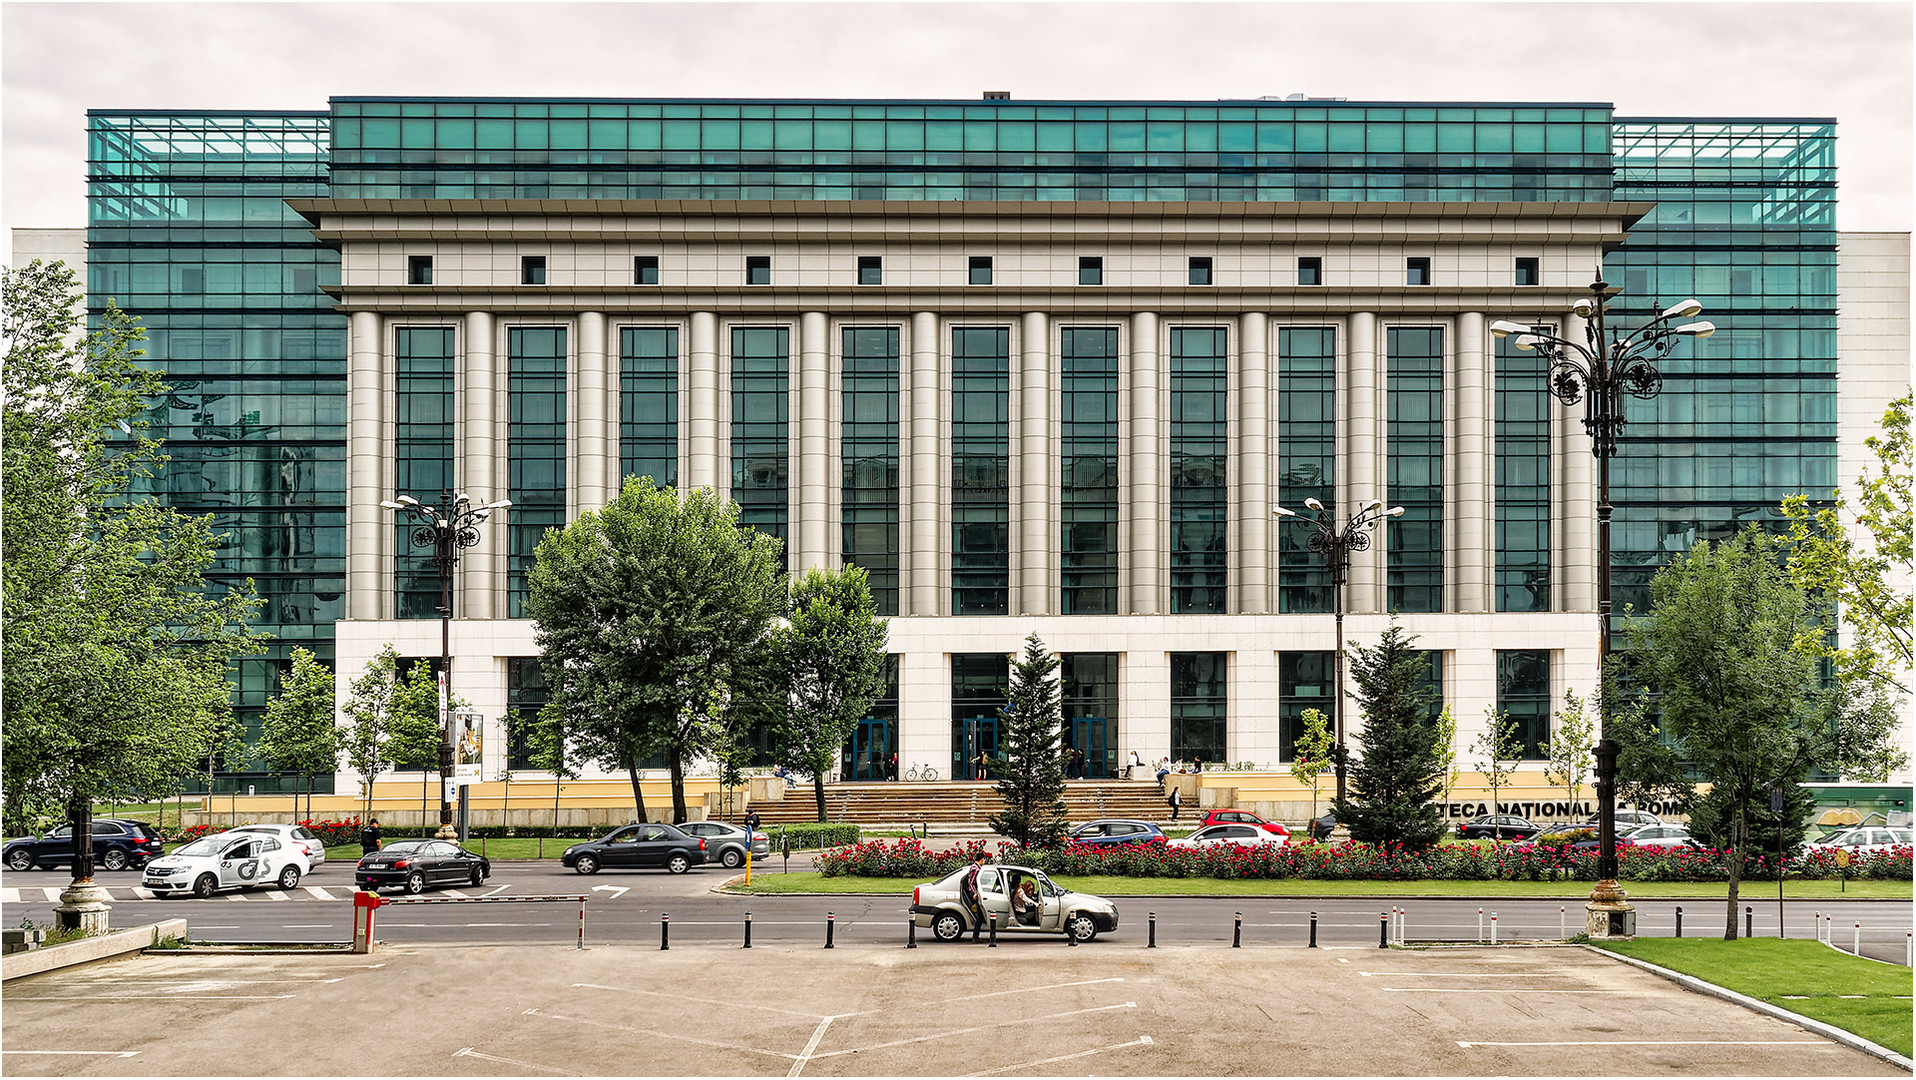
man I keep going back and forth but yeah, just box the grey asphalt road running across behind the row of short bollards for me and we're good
[0,860,1912,963]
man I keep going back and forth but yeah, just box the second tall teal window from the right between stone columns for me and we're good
[1383,326,1445,611]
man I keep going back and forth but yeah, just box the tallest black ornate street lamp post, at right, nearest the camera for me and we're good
[1491,276,1717,936]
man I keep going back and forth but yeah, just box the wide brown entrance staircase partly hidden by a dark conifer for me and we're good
[751,779,1171,831]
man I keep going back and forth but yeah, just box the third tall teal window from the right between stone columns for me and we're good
[1278,326,1341,612]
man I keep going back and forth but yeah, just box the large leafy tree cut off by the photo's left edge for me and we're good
[0,260,259,875]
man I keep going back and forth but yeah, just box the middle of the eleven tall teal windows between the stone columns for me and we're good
[950,326,1012,615]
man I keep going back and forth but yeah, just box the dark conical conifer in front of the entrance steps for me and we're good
[991,634,1065,848]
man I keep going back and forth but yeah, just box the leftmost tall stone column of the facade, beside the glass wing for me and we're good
[347,312,383,619]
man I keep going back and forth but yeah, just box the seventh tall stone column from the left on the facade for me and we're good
[1012,312,1060,615]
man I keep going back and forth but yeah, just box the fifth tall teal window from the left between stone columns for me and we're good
[839,326,899,615]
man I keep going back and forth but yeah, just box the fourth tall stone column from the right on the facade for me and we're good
[1230,312,1270,615]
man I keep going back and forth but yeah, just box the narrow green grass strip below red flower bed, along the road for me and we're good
[734,873,1910,900]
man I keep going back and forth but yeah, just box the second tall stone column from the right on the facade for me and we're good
[1445,312,1496,611]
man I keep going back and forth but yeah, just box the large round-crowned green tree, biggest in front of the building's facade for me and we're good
[529,477,786,821]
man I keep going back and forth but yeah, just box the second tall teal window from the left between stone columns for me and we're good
[506,326,567,619]
